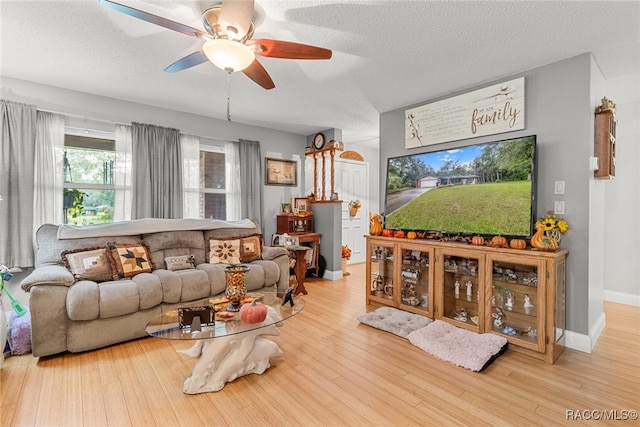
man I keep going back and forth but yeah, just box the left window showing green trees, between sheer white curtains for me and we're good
[63,134,115,225]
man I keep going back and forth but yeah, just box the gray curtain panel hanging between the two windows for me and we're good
[131,123,183,219]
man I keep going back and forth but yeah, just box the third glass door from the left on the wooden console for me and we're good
[436,250,484,332]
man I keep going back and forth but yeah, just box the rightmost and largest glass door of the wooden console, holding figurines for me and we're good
[486,255,546,352]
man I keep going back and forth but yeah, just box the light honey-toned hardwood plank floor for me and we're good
[0,264,640,427]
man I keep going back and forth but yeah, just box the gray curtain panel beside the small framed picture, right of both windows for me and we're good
[238,139,264,227]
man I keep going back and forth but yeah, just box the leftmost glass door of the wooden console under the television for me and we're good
[367,239,397,306]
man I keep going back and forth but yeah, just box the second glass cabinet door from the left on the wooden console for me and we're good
[399,243,433,317]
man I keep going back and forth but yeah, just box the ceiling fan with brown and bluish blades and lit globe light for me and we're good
[99,0,332,89]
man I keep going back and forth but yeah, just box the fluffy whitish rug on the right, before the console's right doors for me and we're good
[407,320,507,372]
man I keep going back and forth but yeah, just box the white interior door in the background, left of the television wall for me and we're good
[335,159,369,264]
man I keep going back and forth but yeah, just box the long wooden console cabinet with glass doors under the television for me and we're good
[365,236,568,363]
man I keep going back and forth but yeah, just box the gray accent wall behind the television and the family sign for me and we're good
[379,54,603,339]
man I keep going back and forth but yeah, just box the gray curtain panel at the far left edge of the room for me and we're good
[0,100,37,267]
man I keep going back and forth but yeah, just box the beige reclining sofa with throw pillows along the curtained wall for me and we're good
[21,219,289,357]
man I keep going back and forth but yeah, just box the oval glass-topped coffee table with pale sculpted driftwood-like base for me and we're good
[145,291,305,394]
